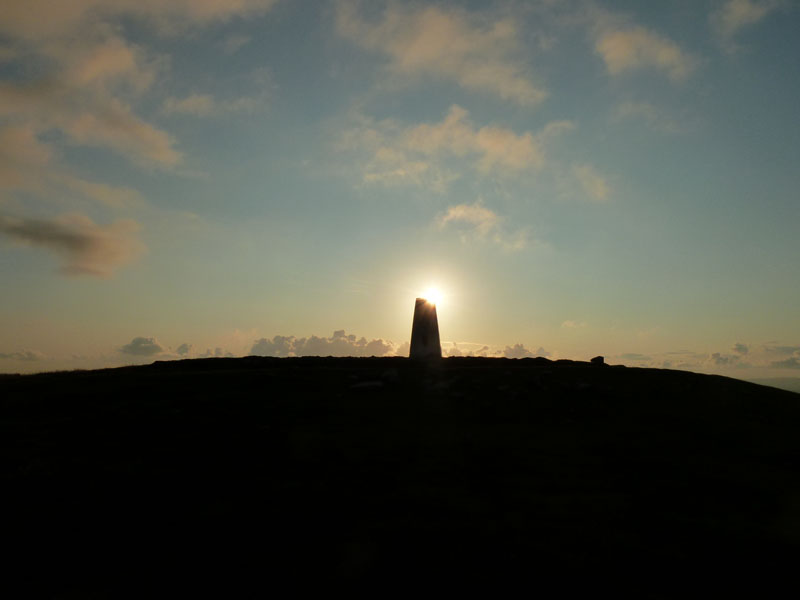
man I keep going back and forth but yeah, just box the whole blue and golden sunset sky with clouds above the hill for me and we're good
[0,0,800,377]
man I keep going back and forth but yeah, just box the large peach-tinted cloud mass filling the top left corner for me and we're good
[0,0,282,176]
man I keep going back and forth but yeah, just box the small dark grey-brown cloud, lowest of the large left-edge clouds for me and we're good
[0,214,144,278]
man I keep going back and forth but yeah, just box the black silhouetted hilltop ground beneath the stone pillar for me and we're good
[0,357,800,598]
